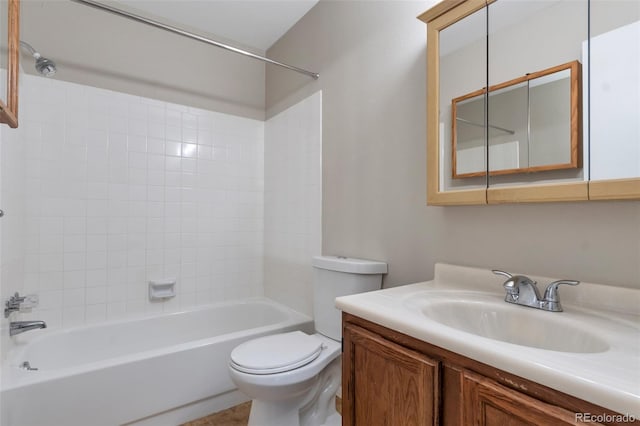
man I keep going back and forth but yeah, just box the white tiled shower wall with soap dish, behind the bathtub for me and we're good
[0,75,264,327]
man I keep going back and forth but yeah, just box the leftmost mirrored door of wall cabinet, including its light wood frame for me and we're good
[419,0,487,205]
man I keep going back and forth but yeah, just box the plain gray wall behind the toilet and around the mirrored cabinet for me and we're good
[266,0,640,287]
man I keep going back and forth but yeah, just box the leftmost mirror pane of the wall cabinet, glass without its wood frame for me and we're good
[439,4,487,191]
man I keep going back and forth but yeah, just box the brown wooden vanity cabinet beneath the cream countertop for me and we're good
[342,313,640,426]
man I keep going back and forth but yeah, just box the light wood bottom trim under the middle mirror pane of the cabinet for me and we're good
[487,182,589,204]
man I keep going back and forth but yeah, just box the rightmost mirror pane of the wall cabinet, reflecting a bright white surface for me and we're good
[583,0,640,181]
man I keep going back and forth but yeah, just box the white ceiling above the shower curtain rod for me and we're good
[117,0,318,51]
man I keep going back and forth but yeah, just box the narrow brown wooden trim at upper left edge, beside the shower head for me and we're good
[0,0,20,129]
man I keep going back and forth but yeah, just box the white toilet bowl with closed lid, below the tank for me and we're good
[229,331,341,426]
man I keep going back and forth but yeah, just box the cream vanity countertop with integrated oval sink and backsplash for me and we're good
[336,264,640,418]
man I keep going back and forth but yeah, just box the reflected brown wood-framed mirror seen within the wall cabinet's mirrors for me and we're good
[451,61,582,179]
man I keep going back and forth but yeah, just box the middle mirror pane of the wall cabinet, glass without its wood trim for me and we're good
[488,0,588,188]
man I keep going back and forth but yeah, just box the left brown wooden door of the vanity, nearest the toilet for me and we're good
[342,324,439,426]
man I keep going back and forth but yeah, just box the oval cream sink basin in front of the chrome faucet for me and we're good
[421,299,609,353]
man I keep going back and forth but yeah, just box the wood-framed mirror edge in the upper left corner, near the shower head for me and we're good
[0,0,20,128]
